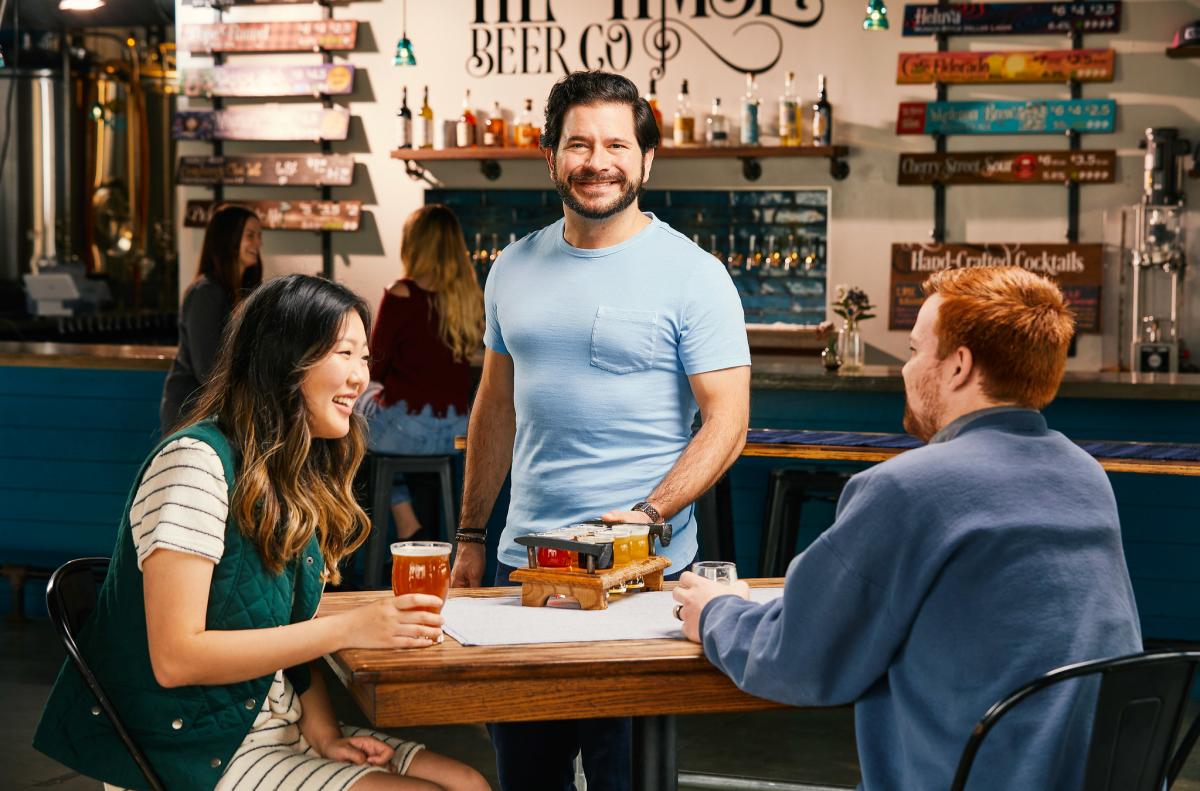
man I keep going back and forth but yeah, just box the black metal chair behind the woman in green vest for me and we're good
[46,557,163,791]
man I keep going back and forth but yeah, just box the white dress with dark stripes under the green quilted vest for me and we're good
[104,437,424,791]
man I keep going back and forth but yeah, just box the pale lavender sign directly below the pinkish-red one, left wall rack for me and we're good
[179,64,354,97]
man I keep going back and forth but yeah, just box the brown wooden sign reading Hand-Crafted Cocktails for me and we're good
[888,242,1104,332]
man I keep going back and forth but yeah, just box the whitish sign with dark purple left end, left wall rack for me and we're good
[170,104,350,140]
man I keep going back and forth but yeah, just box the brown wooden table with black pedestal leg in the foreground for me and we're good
[317,579,785,791]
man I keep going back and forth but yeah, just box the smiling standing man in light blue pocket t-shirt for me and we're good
[451,72,750,791]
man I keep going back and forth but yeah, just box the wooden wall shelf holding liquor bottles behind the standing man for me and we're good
[391,145,850,181]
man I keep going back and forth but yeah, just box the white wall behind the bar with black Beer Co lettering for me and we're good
[176,0,1200,370]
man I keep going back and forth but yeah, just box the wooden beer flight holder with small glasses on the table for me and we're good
[510,520,671,610]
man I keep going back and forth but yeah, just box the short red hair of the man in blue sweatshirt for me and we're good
[922,266,1075,409]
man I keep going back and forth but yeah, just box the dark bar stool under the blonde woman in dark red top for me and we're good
[362,453,457,589]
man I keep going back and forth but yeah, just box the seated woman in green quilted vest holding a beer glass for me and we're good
[35,275,487,791]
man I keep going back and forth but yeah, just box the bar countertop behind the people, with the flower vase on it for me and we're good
[0,341,1200,401]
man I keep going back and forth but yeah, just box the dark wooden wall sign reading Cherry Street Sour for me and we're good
[898,151,1117,186]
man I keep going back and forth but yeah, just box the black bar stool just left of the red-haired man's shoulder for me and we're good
[758,467,852,577]
